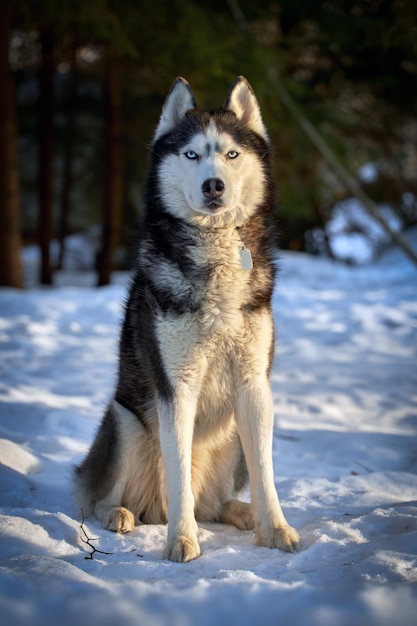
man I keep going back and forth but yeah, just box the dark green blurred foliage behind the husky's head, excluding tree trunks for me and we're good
[9,0,417,254]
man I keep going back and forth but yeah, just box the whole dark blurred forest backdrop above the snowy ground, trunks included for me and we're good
[0,0,417,287]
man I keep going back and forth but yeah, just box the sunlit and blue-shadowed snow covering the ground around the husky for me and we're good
[0,233,417,626]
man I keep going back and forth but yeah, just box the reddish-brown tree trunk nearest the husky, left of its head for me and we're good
[97,57,123,286]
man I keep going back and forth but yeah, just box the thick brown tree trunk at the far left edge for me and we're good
[0,1,23,288]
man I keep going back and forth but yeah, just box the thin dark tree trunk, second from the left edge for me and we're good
[38,23,55,285]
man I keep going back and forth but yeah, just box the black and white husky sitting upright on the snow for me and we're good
[75,76,299,561]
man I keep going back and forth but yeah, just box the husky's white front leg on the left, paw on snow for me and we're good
[158,388,200,562]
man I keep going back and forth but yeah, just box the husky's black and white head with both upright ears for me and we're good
[152,76,269,225]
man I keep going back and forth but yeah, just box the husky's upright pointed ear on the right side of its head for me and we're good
[225,76,268,140]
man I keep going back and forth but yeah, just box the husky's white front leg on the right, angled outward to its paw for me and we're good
[236,379,300,552]
